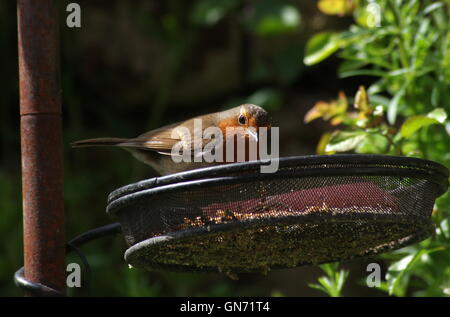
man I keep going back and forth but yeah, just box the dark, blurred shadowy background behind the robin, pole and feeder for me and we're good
[0,0,382,296]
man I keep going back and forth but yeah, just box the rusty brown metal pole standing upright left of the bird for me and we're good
[17,0,65,292]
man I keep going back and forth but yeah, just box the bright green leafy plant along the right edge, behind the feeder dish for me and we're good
[304,0,450,296]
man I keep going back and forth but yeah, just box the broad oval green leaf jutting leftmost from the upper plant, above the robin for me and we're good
[303,32,341,65]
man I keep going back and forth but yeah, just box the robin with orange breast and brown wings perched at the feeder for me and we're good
[72,104,271,175]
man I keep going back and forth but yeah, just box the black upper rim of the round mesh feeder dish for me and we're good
[106,154,449,214]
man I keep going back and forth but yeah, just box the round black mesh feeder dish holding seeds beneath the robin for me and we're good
[107,155,448,273]
